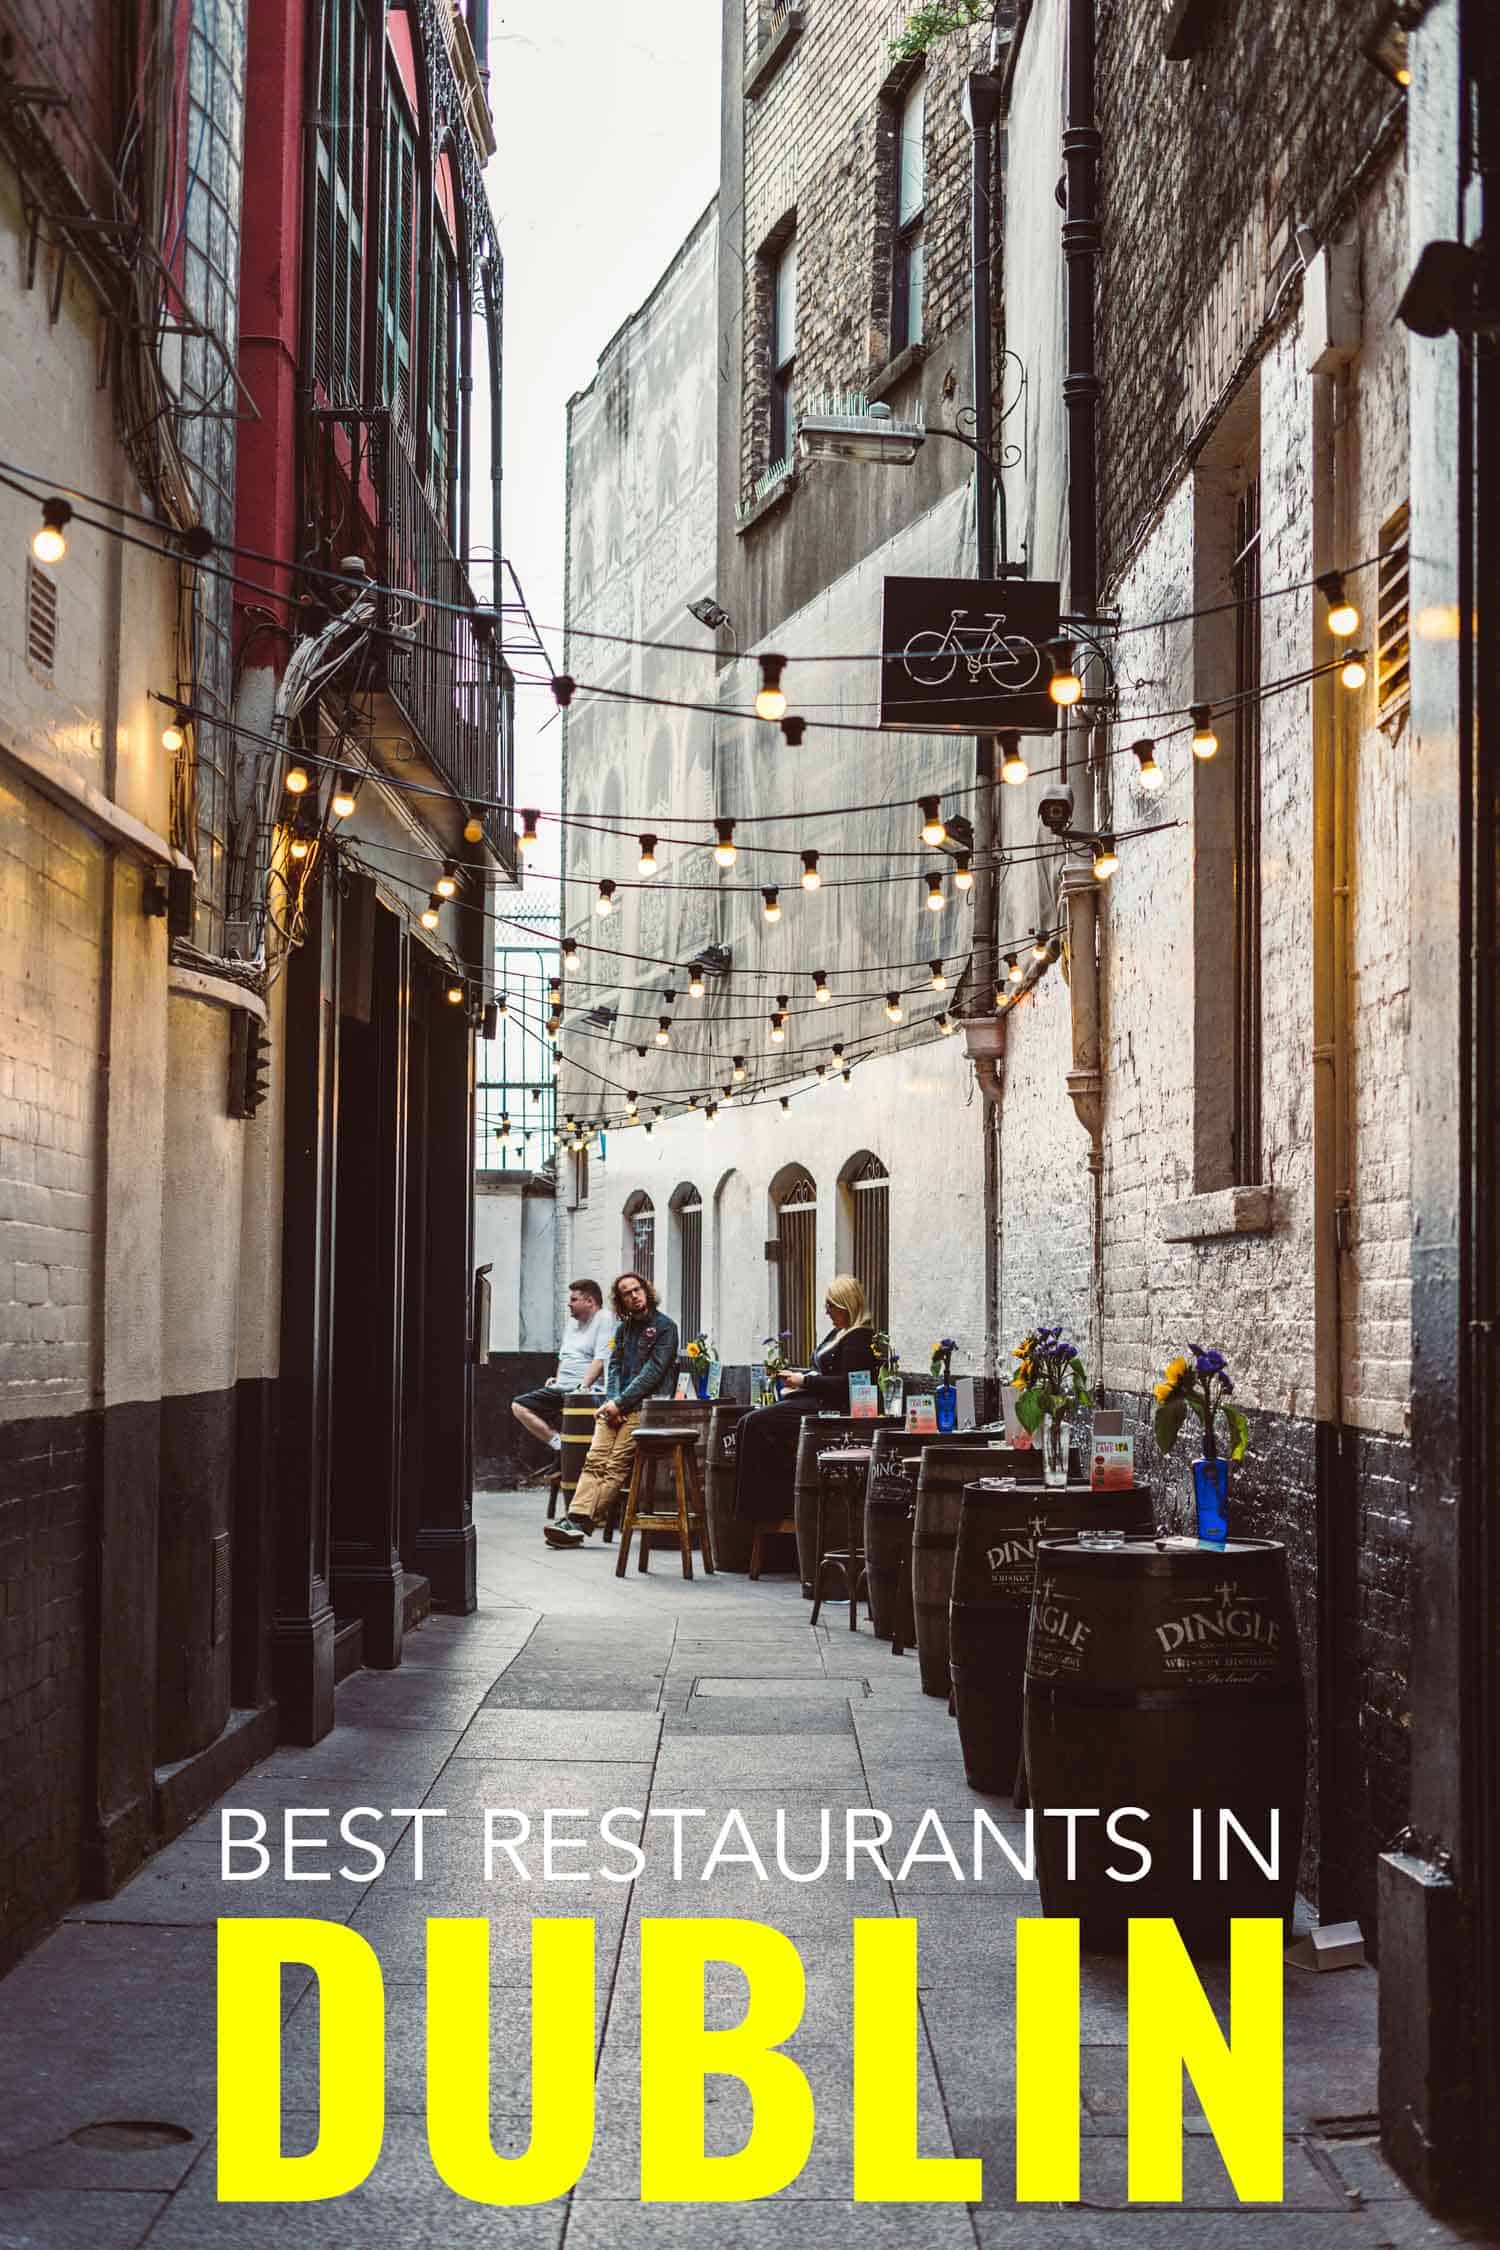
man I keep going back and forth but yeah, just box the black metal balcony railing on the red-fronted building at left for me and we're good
[308,407,515,866]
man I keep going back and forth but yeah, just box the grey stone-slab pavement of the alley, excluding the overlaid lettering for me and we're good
[0,1494,1489,2250]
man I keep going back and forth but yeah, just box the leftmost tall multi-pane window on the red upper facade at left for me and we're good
[313,0,369,403]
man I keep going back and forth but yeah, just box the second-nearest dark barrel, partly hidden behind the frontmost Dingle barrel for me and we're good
[949,1478,1154,1796]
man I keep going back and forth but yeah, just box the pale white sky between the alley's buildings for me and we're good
[474,0,720,868]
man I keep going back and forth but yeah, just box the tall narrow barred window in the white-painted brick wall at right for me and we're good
[1230,477,1262,1188]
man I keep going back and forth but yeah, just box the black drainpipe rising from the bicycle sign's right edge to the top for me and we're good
[1061,0,1102,617]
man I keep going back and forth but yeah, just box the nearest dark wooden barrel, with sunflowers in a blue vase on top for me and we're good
[1023,1539,1307,1953]
